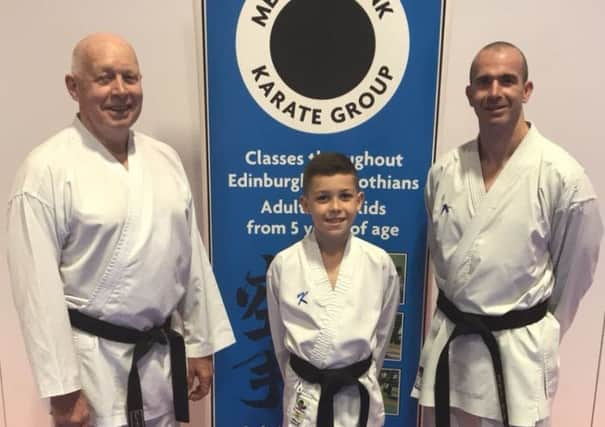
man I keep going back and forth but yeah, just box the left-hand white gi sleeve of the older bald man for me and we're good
[7,192,82,397]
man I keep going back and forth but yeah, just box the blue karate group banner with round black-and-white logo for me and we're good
[200,0,443,427]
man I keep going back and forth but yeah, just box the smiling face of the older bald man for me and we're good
[66,39,143,142]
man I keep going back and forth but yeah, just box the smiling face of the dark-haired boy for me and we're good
[300,174,363,244]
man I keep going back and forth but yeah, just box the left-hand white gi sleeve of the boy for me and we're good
[267,256,289,378]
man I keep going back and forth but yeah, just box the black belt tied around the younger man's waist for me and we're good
[435,291,548,427]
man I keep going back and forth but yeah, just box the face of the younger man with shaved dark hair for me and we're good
[466,47,533,127]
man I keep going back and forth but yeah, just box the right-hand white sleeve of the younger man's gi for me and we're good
[550,175,603,337]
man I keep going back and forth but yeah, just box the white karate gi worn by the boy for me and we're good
[267,231,399,427]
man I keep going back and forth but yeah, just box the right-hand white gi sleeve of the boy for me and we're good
[373,255,400,372]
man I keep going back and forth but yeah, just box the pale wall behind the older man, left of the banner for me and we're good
[0,0,207,427]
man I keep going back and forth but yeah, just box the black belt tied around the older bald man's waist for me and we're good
[69,309,189,427]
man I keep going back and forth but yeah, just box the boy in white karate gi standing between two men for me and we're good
[267,153,399,427]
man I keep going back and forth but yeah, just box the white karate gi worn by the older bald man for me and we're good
[8,119,234,427]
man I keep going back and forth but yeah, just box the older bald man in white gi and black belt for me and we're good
[8,33,234,427]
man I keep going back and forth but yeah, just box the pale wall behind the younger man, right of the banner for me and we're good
[437,0,605,427]
